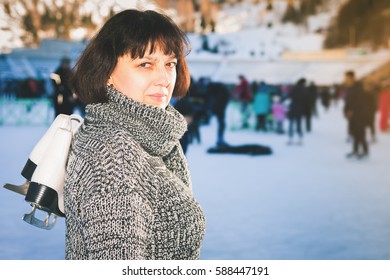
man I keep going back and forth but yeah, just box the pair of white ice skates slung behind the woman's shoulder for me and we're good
[4,114,83,229]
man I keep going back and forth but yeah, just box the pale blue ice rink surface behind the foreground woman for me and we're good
[0,103,390,260]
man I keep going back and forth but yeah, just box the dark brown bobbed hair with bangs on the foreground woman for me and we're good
[72,10,190,104]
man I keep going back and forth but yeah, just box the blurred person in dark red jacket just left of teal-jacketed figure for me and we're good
[233,75,252,128]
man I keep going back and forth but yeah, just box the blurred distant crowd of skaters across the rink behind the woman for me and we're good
[0,58,390,159]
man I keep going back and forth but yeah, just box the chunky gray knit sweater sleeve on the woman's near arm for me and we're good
[76,137,154,260]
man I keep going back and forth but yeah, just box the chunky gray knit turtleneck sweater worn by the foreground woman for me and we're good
[64,87,205,259]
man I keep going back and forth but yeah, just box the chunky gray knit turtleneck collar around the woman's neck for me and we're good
[85,86,187,156]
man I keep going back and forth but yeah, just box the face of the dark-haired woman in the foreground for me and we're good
[108,48,177,108]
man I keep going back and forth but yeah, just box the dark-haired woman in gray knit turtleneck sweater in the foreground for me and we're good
[64,10,205,259]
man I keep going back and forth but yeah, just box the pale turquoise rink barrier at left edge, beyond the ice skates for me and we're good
[0,97,53,126]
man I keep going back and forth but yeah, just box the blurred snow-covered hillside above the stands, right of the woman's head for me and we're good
[190,1,343,59]
